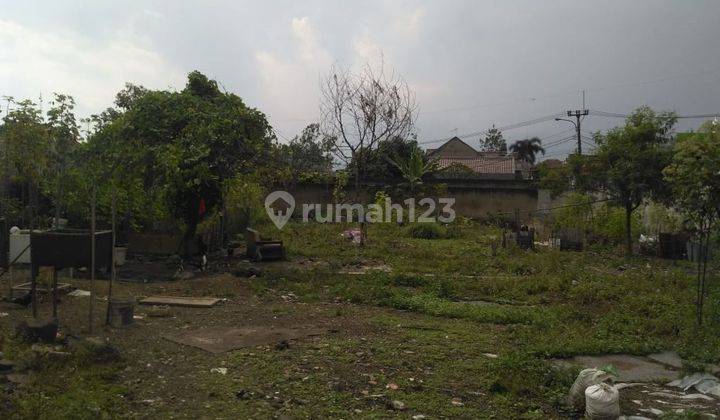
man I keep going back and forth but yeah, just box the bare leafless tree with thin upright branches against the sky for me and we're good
[320,64,417,189]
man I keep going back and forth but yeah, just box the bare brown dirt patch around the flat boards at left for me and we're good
[0,264,382,417]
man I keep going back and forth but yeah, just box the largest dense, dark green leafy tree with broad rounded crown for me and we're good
[86,71,272,253]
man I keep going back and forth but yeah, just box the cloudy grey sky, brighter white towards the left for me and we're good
[0,0,720,158]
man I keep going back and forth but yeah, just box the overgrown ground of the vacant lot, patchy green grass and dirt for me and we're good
[0,223,720,418]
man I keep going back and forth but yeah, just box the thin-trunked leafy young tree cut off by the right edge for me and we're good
[663,122,720,323]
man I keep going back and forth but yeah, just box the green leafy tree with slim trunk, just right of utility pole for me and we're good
[589,107,676,255]
